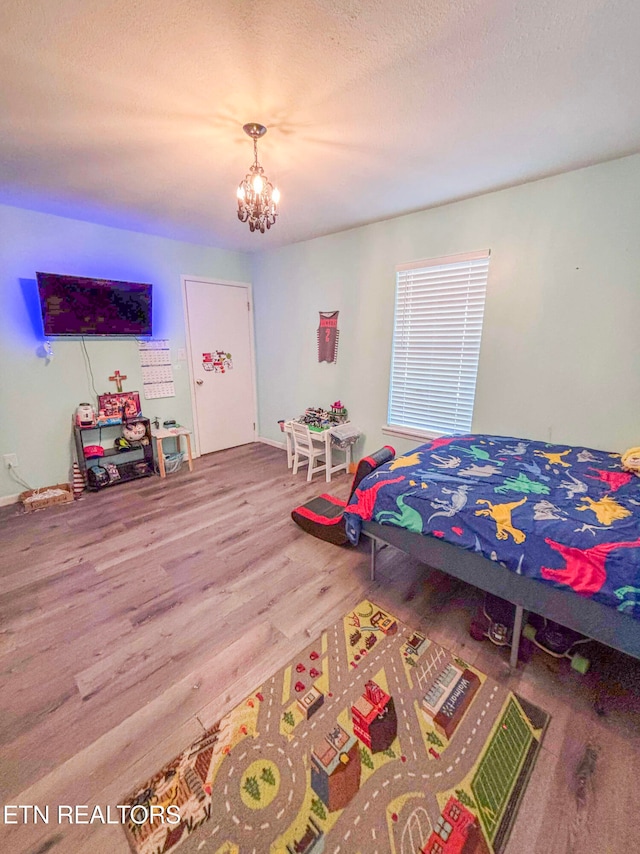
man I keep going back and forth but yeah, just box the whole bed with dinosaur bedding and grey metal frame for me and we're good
[345,434,640,667]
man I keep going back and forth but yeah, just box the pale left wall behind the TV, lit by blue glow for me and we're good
[0,204,251,496]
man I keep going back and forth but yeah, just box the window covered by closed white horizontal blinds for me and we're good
[387,251,489,437]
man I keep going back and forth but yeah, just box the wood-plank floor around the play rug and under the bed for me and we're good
[0,444,640,854]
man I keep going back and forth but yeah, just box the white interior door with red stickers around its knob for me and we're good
[184,279,256,454]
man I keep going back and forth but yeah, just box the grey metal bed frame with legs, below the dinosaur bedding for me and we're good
[362,522,640,668]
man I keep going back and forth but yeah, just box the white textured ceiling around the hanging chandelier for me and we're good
[0,0,640,251]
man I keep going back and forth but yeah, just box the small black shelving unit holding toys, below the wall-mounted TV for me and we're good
[73,417,154,492]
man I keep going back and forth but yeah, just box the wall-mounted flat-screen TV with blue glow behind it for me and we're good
[36,273,151,335]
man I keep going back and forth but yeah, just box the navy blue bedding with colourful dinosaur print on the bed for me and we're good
[345,434,640,620]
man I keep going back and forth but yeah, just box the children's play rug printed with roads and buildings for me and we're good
[121,601,548,854]
